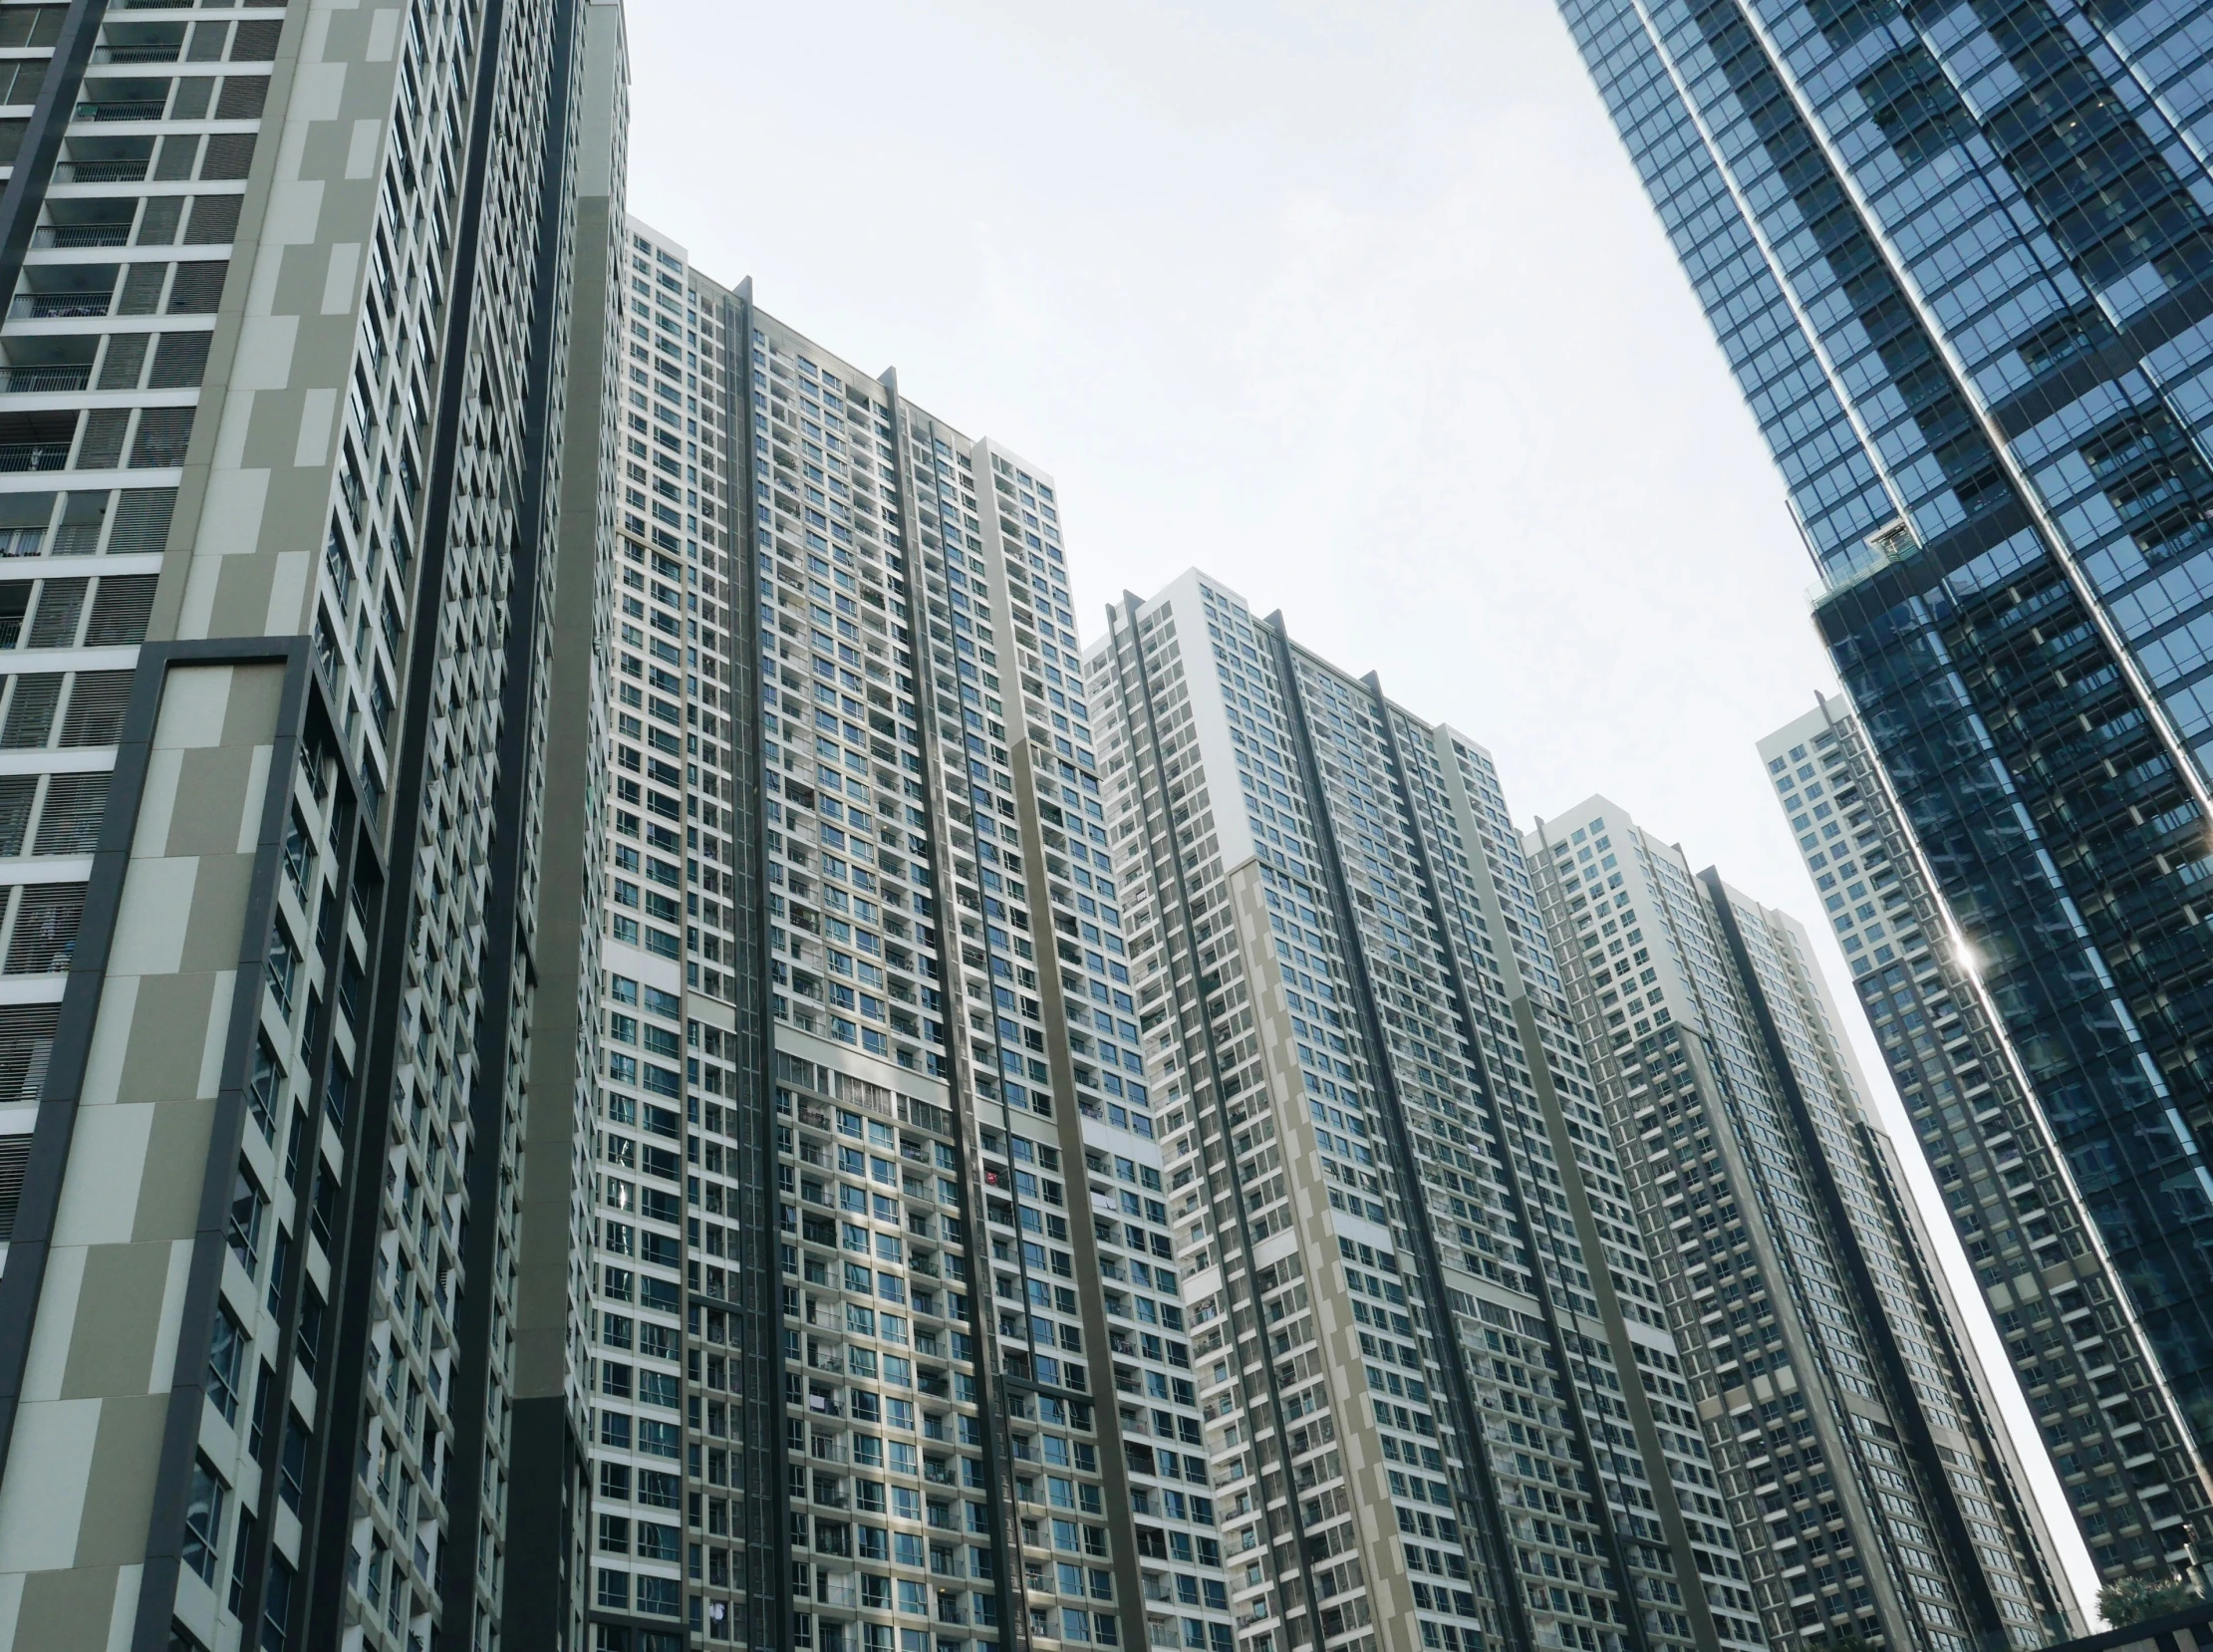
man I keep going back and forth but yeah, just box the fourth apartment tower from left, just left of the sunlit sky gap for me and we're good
[1526,798,2075,1650]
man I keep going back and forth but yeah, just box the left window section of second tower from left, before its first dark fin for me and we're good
[569,221,743,1652]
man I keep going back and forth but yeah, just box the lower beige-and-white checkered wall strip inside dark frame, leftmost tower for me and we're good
[0,666,290,1627]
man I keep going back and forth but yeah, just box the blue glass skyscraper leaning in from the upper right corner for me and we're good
[1562,0,2213,1513]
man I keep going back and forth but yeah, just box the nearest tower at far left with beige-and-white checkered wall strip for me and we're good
[0,0,604,1652]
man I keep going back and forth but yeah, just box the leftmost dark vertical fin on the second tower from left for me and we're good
[721,279,792,1652]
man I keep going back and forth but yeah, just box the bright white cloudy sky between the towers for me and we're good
[629,0,2089,1599]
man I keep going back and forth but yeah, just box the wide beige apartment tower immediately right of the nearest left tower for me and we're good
[589,223,1235,1652]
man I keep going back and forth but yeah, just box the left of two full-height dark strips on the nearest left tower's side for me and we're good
[299,0,507,1648]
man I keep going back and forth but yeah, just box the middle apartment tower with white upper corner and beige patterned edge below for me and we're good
[1087,573,1766,1652]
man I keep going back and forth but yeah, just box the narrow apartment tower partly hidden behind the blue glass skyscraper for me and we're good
[1760,696,2209,1579]
